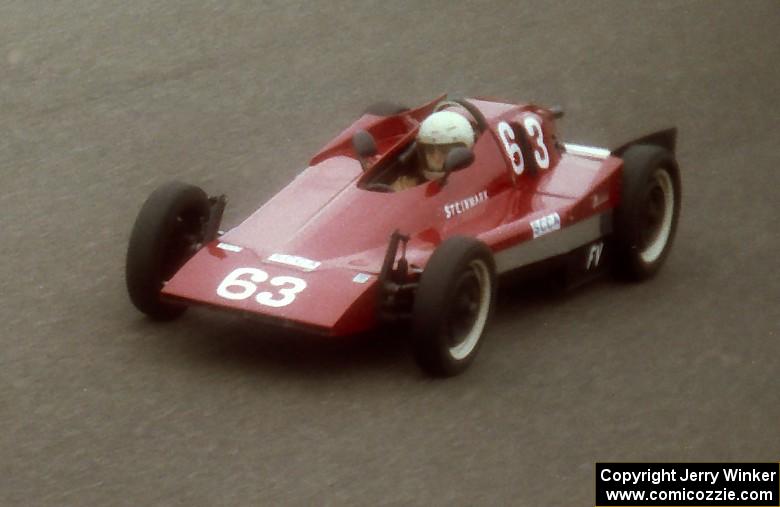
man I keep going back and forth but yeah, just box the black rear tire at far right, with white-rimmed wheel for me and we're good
[614,144,681,281]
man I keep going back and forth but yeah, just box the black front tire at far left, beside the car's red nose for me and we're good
[125,181,209,320]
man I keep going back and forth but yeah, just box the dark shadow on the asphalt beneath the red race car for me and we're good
[129,272,614,378]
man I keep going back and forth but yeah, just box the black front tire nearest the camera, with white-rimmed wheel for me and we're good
[412,236,496,377]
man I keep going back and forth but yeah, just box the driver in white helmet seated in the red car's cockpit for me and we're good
[391,111,474,192]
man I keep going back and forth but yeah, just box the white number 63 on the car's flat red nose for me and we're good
[217,268,306,308]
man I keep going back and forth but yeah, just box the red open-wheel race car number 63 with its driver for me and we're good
[126,97,680,376]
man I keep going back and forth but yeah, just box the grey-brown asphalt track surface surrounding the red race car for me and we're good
[0,0,780,506]
